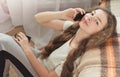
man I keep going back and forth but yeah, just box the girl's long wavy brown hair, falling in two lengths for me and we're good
[41,7,117,77]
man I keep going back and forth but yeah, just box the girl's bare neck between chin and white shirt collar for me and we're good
[70,30,89,48]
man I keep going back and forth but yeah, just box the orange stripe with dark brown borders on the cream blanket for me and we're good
[101,35,120,77]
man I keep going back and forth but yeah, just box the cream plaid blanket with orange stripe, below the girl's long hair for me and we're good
[74,34,120,77]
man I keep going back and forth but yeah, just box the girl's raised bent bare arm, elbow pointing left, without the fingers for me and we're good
[35,8,76,30]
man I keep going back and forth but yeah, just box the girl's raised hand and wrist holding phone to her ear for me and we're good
[61,8,85,21]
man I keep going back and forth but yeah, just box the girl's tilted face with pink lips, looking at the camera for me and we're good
[79,9,107,35]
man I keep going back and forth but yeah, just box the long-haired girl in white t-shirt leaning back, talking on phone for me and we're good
[0,7,116,77]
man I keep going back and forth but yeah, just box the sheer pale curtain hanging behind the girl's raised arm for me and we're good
[3,0,99,47]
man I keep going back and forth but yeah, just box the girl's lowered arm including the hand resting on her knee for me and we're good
[14,32,59,77]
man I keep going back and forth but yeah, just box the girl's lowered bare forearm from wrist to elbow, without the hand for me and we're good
[24,48,58,77]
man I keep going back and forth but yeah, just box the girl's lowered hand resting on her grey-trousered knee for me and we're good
[14,32,31,51]
